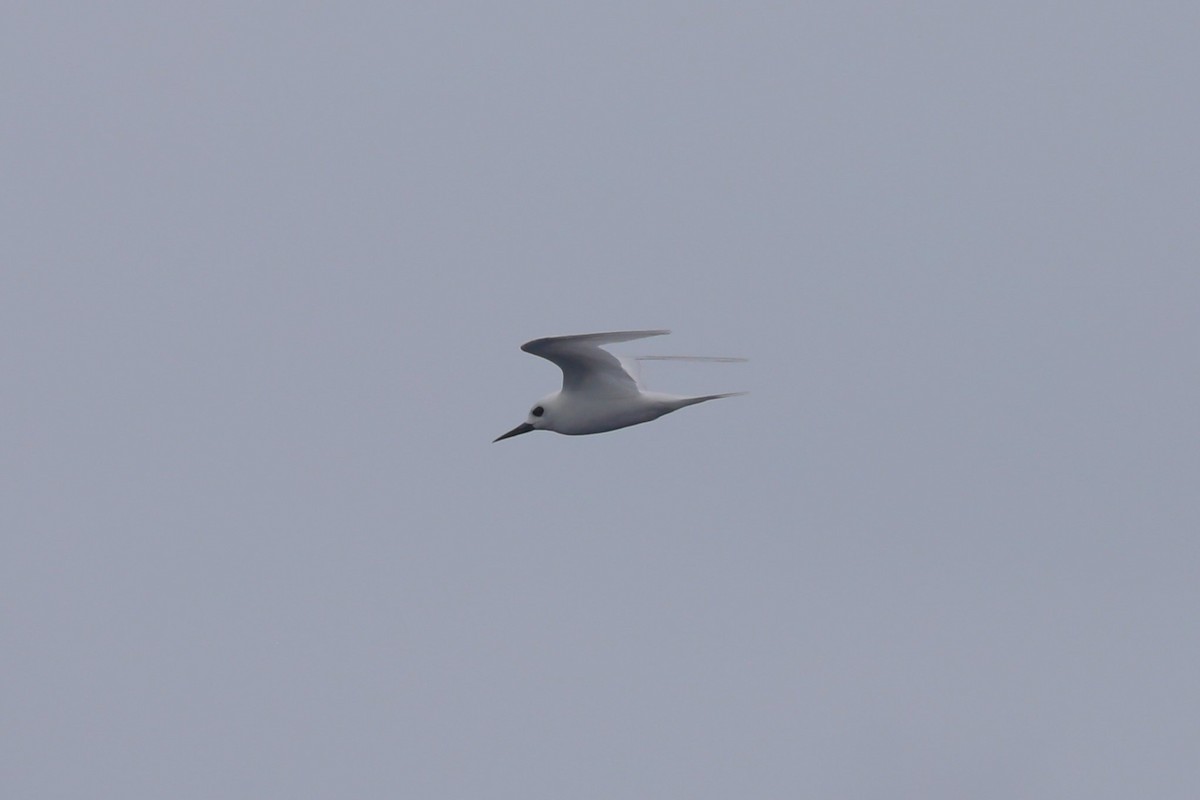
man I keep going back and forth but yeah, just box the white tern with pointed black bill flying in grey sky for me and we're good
[493,331,745,444]
